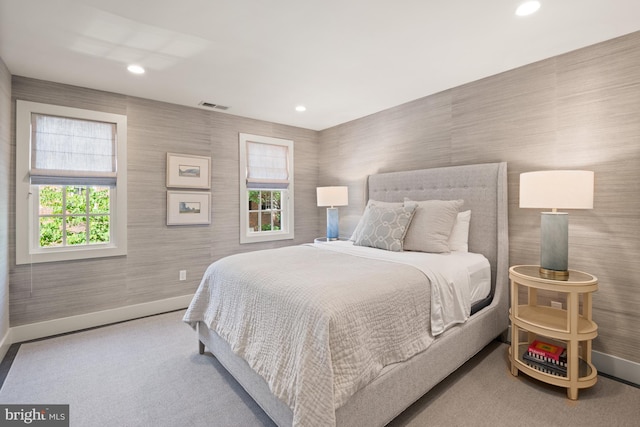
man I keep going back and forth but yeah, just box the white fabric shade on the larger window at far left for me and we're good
[30,113,117,186]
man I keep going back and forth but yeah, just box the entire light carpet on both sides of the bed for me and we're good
[0,311,640,427]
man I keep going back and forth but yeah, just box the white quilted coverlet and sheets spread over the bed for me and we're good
[184,242,489,426]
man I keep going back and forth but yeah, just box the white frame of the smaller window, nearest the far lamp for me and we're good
[238,133,295,244]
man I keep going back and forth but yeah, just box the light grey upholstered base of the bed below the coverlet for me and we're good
[198,300,504,427]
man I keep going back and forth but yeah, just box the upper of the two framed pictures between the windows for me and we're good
[167,153,211,189]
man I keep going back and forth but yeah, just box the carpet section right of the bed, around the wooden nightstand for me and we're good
[389,342,640,427]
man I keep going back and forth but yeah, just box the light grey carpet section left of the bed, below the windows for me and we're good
[0,311,274,427]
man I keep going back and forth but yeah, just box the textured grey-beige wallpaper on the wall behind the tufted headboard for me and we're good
[319,33,640,362]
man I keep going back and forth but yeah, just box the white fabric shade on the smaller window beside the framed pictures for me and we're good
[247,141,289,189]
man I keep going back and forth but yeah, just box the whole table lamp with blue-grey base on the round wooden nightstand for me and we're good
[520,170,594,280]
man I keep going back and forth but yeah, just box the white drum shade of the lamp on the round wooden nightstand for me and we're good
[520,170,594,209]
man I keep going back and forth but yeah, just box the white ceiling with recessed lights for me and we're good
[0,0,640,130]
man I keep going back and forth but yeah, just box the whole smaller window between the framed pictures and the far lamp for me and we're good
[240,133,294,243]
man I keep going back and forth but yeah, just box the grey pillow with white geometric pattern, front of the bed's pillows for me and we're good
[354,204,415,252]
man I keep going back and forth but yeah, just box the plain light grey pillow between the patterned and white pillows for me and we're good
[404,198,464,253]
